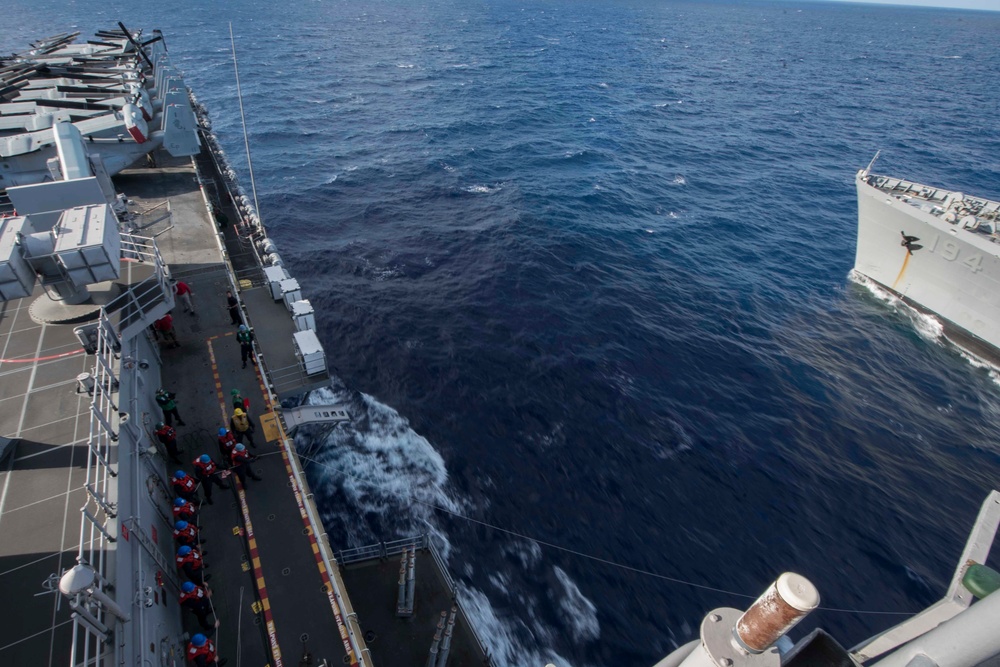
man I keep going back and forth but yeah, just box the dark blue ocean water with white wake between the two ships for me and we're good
[0,0,1000,667]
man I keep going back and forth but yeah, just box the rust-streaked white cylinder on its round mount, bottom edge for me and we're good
[655,572,819,667]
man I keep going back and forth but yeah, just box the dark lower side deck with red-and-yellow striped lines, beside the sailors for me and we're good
[121,149,354,665]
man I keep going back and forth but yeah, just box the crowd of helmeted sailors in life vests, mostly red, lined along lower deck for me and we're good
[164,389,261,667]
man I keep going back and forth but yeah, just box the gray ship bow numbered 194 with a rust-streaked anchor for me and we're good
[854,170,1000,362]
